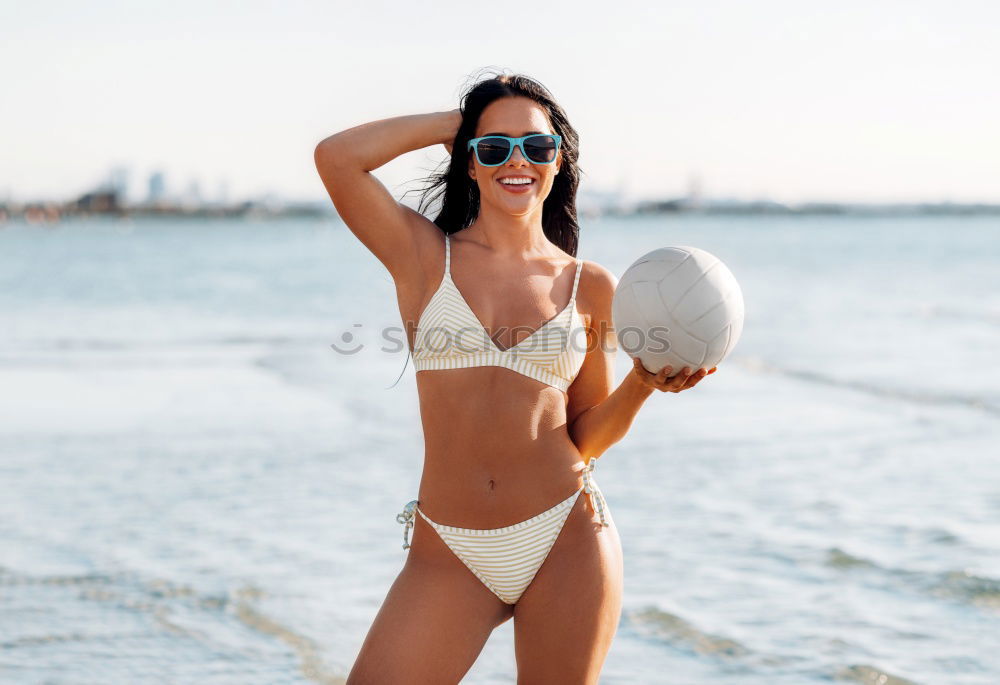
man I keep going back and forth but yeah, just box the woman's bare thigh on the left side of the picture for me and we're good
[347,516,512,685]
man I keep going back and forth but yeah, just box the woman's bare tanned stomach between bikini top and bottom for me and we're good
[417,367,583,528]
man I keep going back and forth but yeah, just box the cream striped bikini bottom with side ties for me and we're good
[396,459,609,604]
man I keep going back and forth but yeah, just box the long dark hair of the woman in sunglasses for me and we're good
[404,73,583,257]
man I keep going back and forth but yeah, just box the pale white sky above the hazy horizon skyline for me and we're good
[0,0,1000,202]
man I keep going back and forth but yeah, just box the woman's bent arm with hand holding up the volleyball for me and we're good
[567,262,715,461]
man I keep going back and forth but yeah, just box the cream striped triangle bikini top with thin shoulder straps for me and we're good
[413,234,587,392]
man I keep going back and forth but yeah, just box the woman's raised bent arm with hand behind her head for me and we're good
[314,109,462,283]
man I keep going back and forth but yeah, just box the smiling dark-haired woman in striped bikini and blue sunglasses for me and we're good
[316,67,704,684]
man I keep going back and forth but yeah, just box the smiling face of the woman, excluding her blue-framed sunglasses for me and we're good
[469,97,562,215]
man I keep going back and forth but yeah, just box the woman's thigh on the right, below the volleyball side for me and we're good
[514,494,623,685]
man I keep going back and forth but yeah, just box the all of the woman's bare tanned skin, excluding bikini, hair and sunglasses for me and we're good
[317,97,715,684]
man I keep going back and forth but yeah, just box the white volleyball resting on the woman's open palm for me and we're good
[612,246,743,375]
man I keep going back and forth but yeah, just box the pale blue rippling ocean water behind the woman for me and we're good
[0,216,1000,685]
